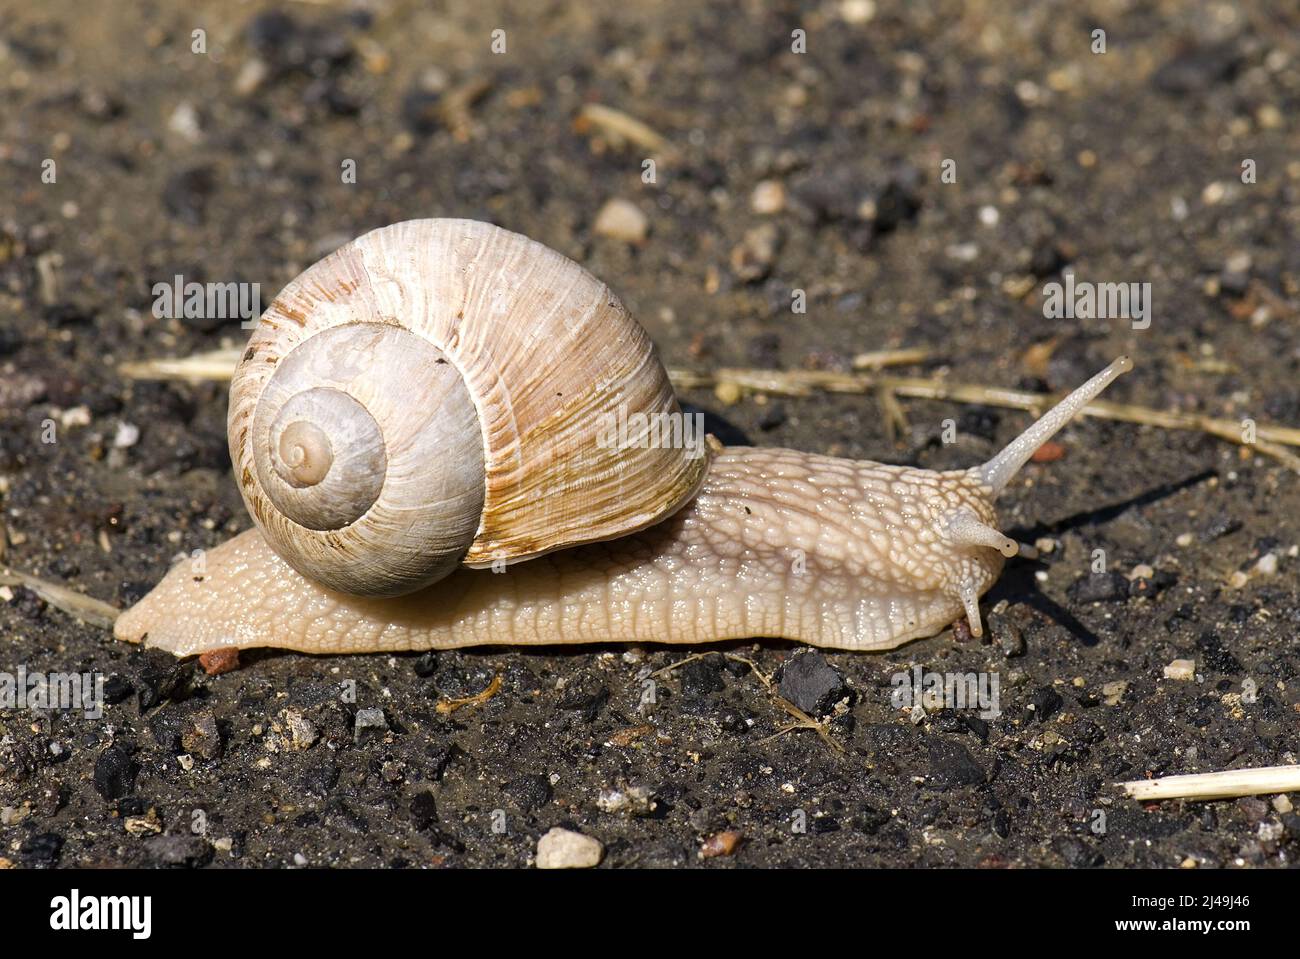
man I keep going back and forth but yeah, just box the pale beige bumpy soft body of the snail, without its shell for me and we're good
[114,357,1131,656]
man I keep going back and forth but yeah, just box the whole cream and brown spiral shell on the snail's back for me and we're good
[228,220,709,595]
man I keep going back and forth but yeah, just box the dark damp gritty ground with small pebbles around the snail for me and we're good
[0,0,1300,868]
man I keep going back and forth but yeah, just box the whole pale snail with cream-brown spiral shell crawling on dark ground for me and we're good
[114,220,1132,656]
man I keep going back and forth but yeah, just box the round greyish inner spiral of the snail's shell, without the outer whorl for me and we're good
[243,322,484,595]
